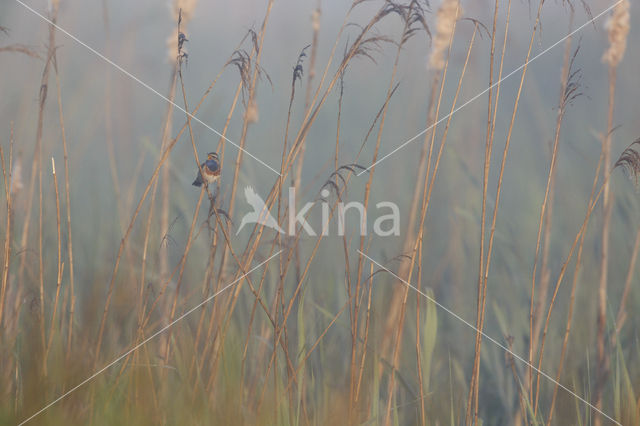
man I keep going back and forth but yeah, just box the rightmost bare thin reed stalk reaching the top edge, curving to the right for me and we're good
[473,0,544,424]
